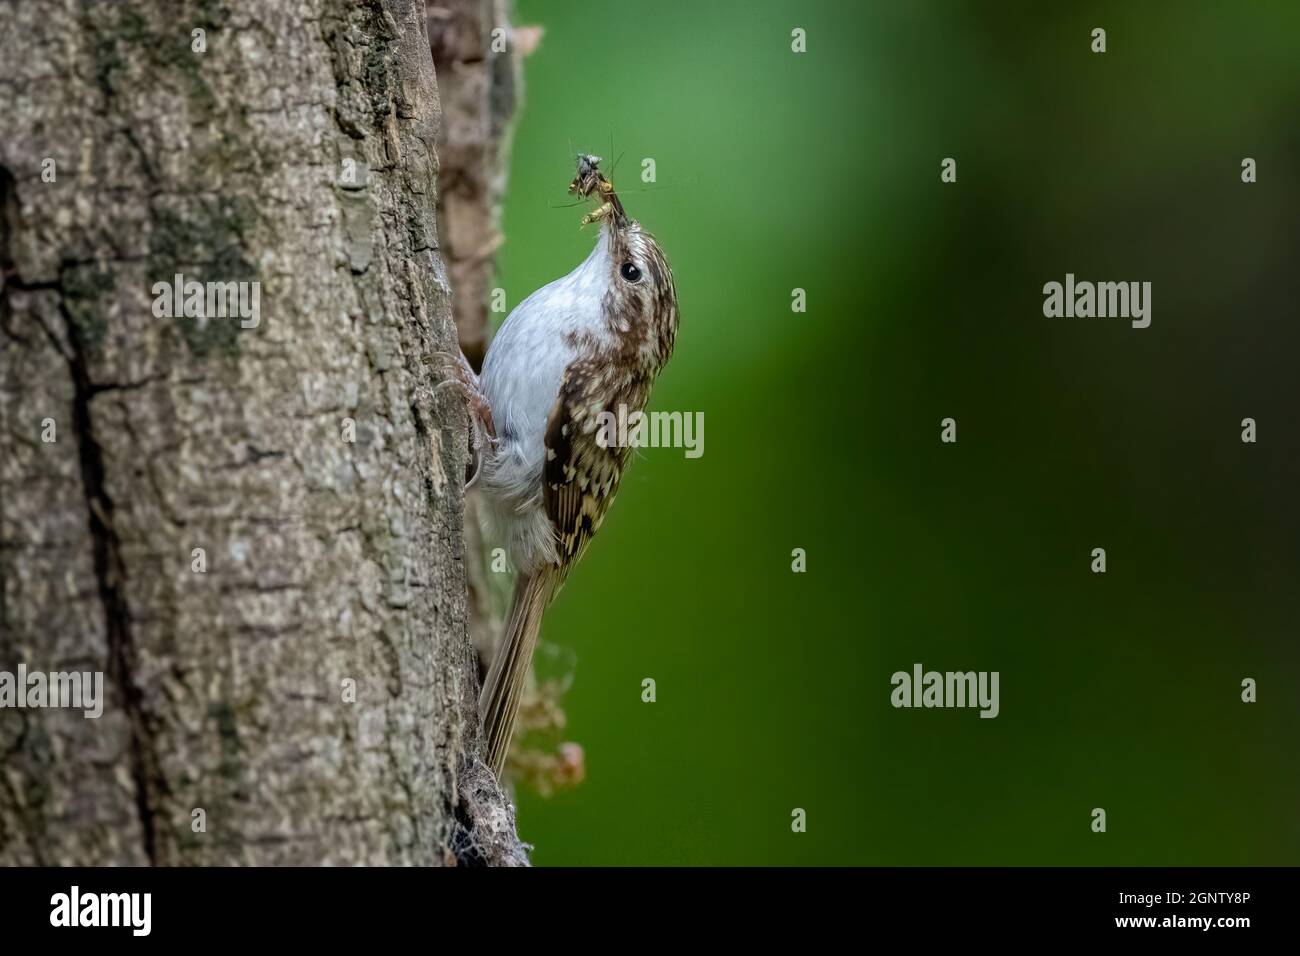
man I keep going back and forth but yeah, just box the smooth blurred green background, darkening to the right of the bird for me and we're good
[488,0,1300,865]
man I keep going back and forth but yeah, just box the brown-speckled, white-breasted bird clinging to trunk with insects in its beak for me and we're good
[458,153,677,777]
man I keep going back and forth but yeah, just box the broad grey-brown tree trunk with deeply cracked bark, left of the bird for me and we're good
[0,0,524,864]
